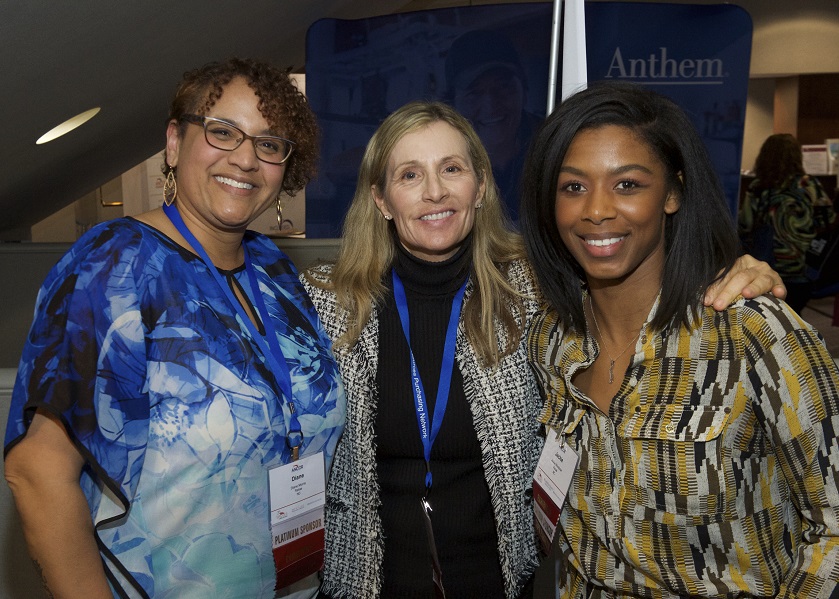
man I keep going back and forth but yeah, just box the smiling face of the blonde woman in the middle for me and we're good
[372,121,484,262]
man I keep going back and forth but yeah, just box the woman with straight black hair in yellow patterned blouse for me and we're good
[522,83,839,598]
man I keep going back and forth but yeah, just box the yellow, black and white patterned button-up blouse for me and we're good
[529,296,839,599]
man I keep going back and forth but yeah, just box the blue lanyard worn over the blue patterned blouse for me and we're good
[163,204,303,460]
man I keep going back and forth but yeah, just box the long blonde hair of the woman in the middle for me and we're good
[306,102,525,366]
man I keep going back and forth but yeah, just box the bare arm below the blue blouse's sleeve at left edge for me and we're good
[6,410,113,599]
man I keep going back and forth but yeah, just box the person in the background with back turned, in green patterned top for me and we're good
[738,133,836,313]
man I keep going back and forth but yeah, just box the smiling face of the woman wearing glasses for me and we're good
[166,78,286,237]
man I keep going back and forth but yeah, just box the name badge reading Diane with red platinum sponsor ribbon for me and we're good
[268,452,326,589]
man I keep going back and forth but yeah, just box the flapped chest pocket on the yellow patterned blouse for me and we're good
[617,397,737,526]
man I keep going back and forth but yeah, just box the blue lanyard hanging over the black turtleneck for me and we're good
[391,270,466,489]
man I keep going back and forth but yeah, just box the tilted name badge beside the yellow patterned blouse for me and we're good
[533,431,580,542]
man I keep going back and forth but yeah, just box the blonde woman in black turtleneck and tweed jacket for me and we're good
[303,102,788,599]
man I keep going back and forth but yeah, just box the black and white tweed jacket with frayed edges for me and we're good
[301,262,543,599]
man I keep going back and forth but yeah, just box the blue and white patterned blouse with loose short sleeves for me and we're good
[6,219,345,599]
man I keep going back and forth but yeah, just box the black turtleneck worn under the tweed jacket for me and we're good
[371,237,504,599]
